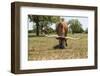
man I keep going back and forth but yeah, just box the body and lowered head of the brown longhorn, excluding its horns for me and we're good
[56,18,68,49]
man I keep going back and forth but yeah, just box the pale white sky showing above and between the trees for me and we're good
[28,16,88,30]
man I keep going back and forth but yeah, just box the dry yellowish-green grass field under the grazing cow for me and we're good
[28,34,88,60]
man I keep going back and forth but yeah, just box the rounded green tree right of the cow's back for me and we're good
[68,19,84,33]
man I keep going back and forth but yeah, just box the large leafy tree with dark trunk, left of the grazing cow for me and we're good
[28,15,60,36]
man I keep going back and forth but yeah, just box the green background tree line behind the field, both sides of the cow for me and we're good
[28,15,88,36]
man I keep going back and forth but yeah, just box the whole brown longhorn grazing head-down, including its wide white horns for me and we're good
[46,19,80,49]
